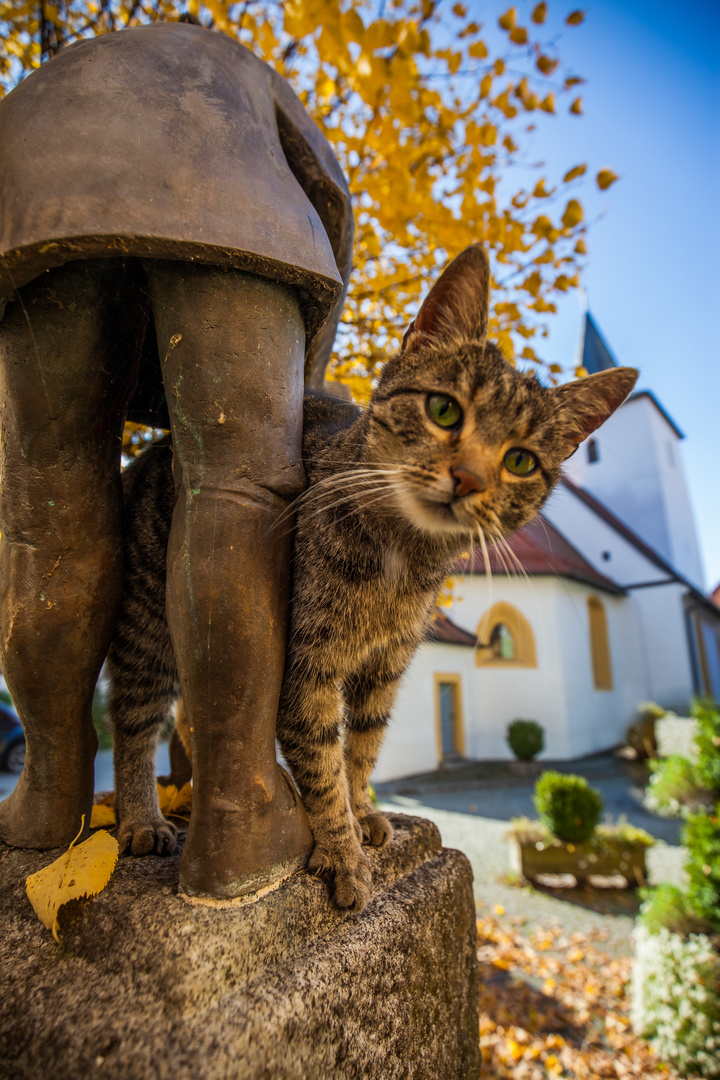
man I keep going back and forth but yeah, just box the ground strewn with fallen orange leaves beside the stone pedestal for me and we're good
[477,907,678,1080]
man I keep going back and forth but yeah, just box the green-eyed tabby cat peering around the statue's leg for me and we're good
[109,245,638,912]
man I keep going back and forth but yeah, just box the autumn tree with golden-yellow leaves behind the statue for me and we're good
[0,0,615,399]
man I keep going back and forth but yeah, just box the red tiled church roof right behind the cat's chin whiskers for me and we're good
[454,514,623,595]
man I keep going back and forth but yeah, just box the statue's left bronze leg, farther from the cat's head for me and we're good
[0,259,132,848]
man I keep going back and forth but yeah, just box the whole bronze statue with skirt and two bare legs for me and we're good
[0,23,353,897]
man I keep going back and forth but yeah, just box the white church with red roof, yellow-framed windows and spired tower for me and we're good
[373,314,720,781]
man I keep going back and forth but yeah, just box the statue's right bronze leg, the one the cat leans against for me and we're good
[145,262,311,897]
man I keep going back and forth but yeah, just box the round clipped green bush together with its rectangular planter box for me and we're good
[510,772,653,887]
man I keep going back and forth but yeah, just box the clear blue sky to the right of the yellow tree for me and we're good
[468,0,720,588]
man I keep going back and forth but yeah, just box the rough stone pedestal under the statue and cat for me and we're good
[0,815,479,1080]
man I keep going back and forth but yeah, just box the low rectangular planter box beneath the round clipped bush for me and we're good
[510,835,648,889]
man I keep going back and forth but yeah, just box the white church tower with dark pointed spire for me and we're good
[565,312,704,591]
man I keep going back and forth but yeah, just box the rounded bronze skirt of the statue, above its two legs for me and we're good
[0,23,353,389]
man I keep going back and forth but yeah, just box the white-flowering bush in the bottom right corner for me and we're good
[630,920,720,1080]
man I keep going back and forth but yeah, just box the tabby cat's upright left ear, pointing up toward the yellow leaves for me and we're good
[403,244,490,350]
